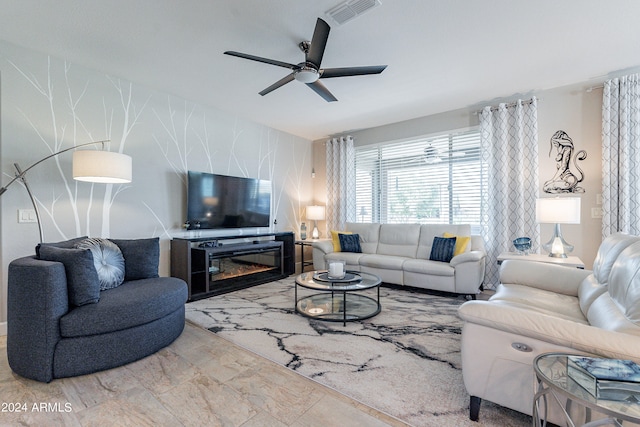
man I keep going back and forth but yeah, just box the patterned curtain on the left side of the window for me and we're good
[326,136,356,230]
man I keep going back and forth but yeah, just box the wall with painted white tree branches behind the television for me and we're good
[0,42,313,325]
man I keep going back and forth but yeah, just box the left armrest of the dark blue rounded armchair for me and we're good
[7,257,69,382]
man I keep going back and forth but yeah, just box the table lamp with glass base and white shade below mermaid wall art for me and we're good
[536,197,580,258]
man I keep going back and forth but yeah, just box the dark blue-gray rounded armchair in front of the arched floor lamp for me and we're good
[7,239,187,382]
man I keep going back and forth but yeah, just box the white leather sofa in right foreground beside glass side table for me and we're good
[459,233,640,425]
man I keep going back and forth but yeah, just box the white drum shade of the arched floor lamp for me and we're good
[73,150,132,184]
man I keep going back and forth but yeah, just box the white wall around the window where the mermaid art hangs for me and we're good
[313,82,602,268]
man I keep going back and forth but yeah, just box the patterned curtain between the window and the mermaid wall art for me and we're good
[479,97,540,287]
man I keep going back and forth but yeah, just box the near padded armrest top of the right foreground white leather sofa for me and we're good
[458,300,640,363]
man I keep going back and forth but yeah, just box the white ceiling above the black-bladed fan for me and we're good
[0,0,640,140]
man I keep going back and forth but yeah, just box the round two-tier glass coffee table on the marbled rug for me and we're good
[295,270,382,325]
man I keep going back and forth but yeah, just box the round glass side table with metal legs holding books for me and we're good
[533,353,640,427]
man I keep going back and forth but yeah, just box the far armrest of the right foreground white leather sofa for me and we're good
[500,260,591,296]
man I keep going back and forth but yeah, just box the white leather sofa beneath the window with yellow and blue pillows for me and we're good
[313,223,486,297]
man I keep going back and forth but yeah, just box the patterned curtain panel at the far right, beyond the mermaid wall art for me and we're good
[602,74,640,239]
